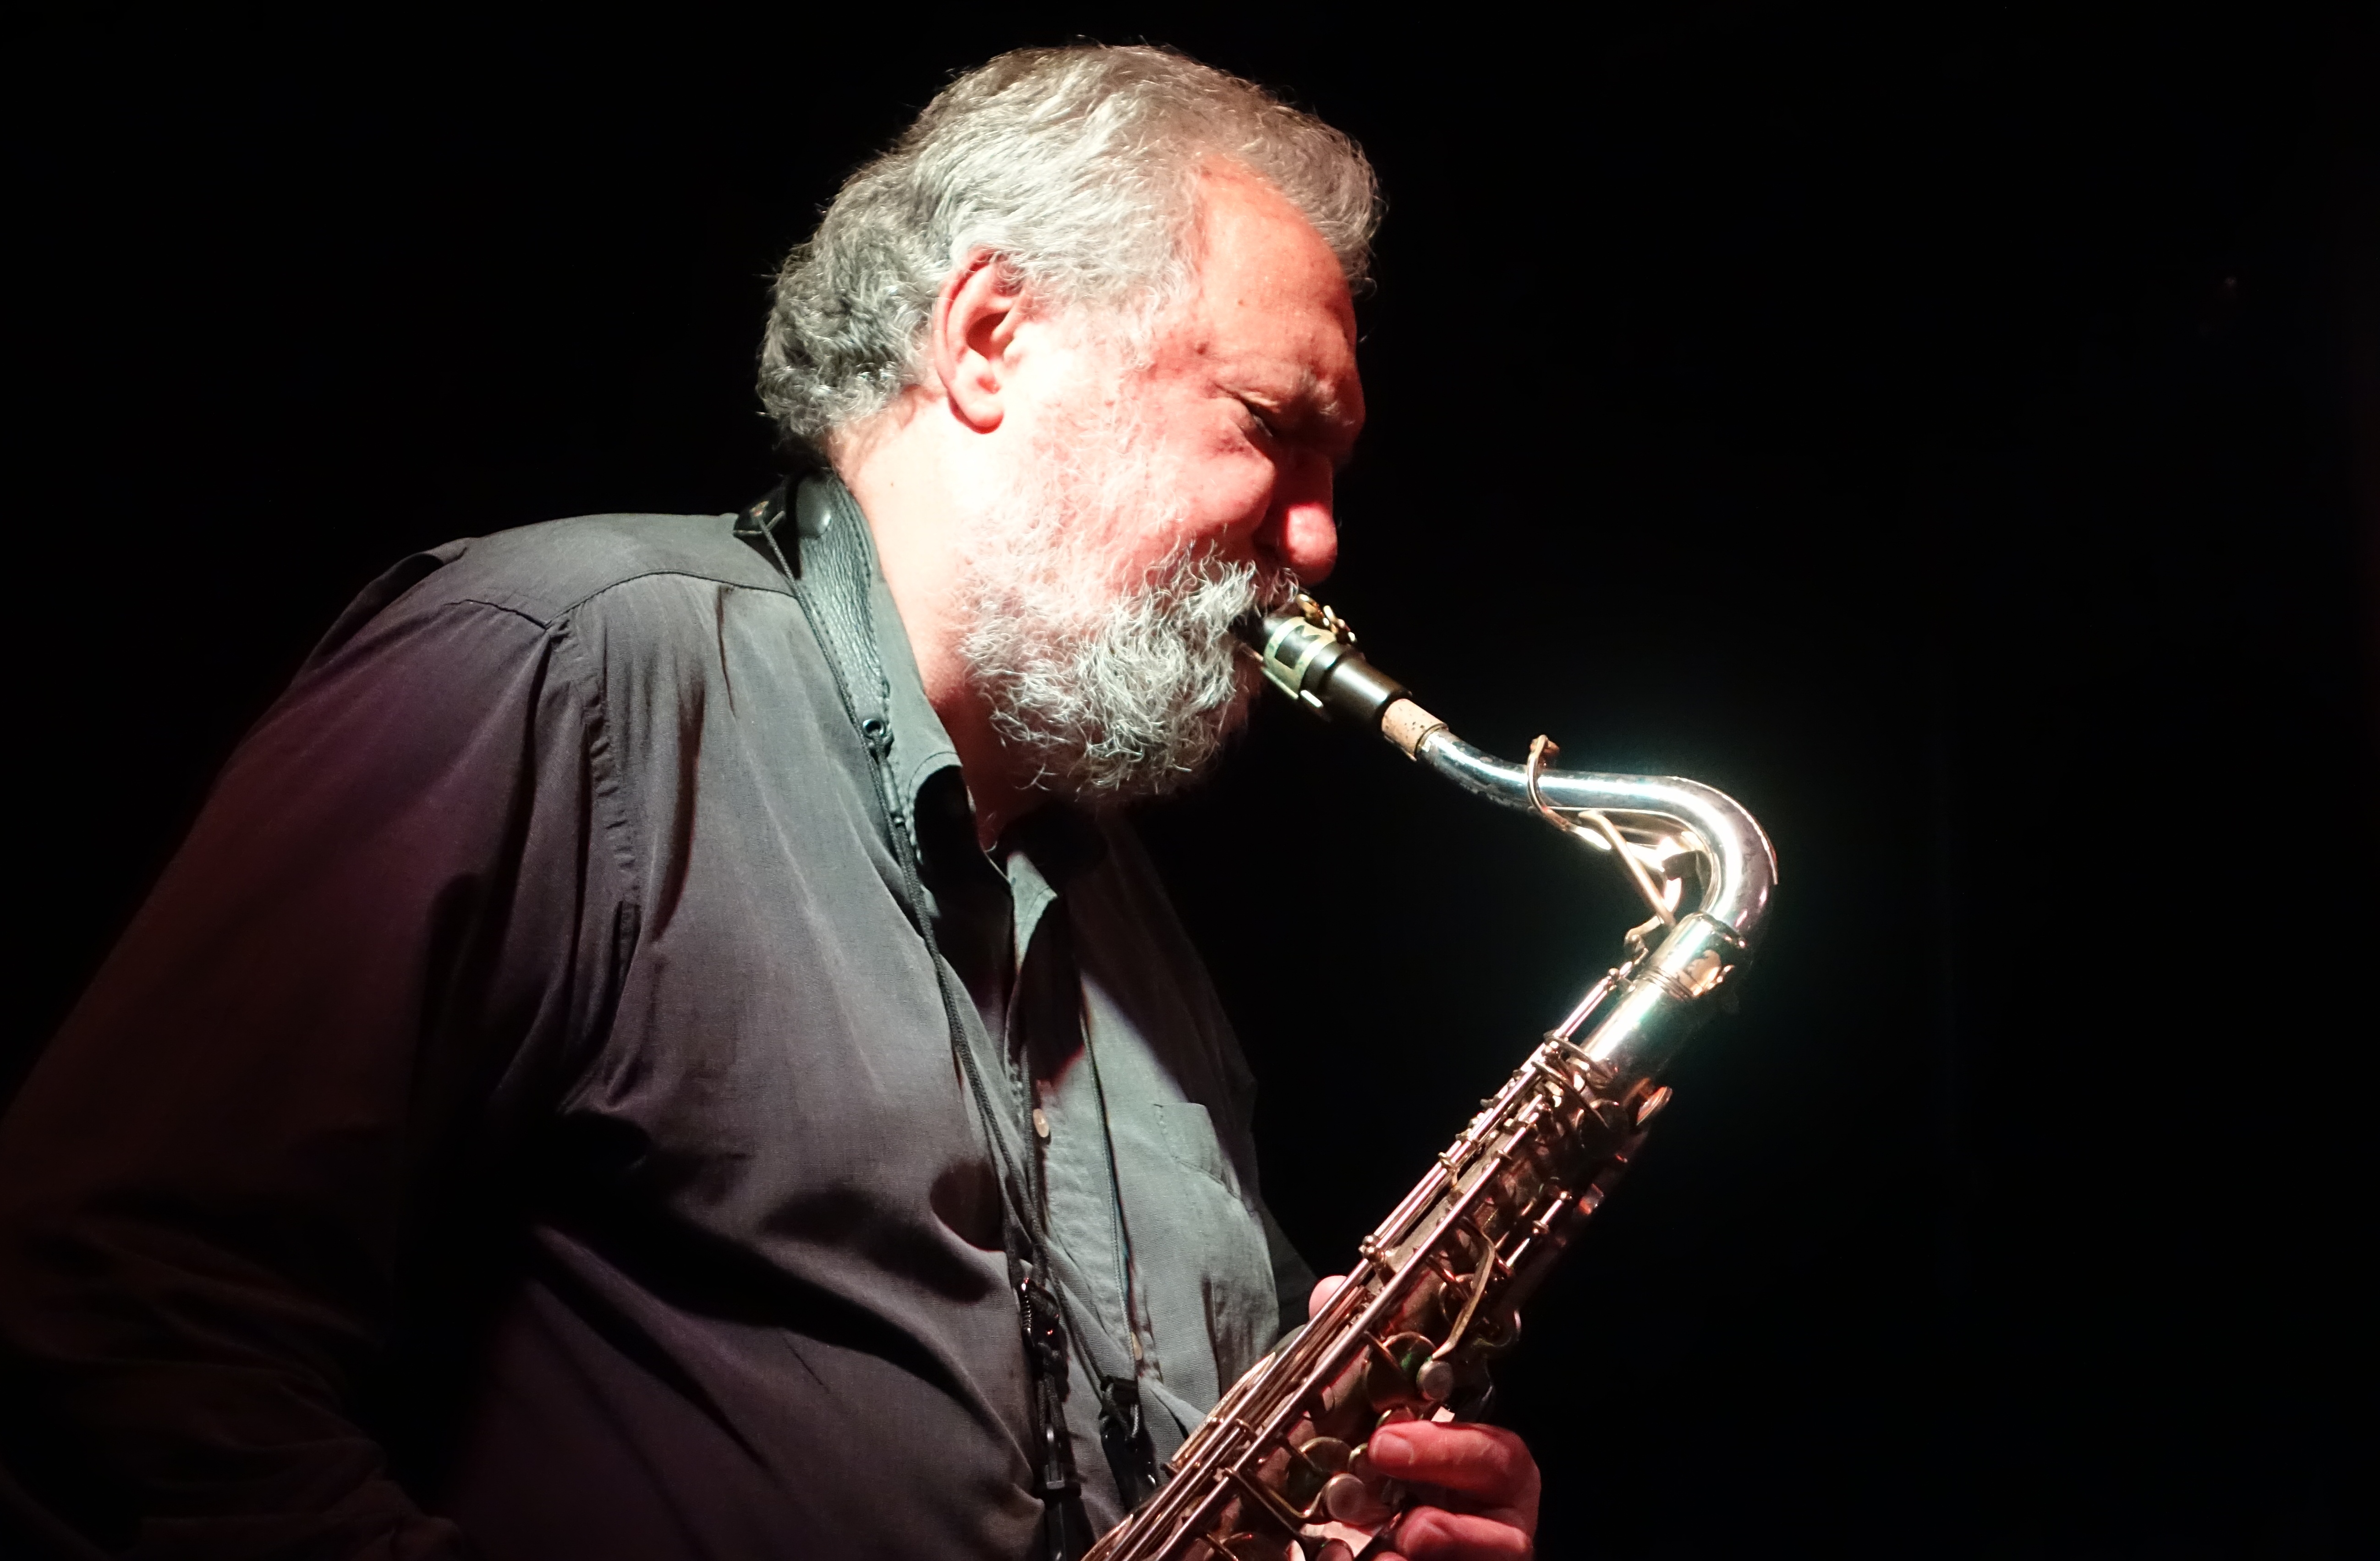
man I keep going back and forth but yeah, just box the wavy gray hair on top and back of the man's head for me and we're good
[759,45,1378,450]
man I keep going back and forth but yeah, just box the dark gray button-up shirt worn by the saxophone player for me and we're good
[0,495,1309,1561]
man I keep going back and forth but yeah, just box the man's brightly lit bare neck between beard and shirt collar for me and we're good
[835,409,1045,849]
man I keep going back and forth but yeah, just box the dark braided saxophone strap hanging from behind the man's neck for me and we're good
[735,476,1095,1561]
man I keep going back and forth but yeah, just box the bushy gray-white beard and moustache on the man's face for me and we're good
[959,388,1297,807]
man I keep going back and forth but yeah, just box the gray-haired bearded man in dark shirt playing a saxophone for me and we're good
[0,48,1537,1559]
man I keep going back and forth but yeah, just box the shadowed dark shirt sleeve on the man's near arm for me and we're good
[0,566,631,1556]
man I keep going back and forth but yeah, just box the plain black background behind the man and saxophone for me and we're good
[18,5,2380,1559]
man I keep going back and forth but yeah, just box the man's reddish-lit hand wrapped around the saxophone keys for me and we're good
[1307,1273,1537,1561]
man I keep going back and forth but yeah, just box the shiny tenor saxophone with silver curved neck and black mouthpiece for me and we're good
[1085,595,1776,1561]
